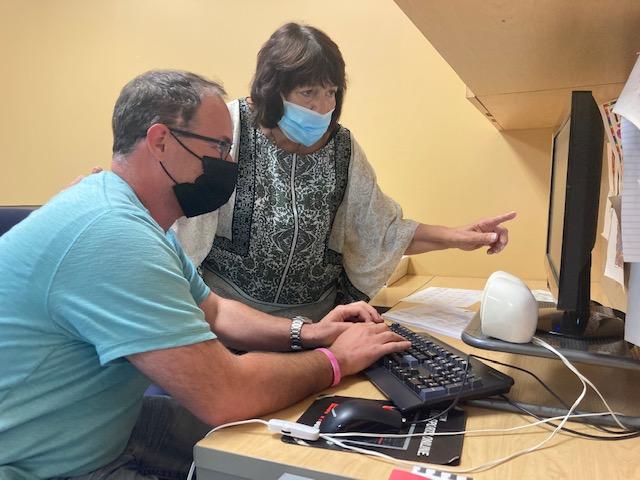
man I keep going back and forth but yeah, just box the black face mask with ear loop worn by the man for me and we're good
[160,130,238,217]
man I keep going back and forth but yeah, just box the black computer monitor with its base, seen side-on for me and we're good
[538,91,624,338]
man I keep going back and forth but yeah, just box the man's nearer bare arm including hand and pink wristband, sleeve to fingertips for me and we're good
[127,322,411,424]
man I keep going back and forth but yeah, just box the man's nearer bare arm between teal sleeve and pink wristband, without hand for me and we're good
[128,340,333,425]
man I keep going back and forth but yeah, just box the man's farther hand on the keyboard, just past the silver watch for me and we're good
[302,302,382,348]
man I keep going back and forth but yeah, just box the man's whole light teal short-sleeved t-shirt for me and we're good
[0,172,216,479]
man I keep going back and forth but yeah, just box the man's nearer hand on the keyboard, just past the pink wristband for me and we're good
[330,323,411,376]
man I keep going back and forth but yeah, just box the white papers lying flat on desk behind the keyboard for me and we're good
[382,302,474,338]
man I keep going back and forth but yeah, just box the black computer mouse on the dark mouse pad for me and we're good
[320,399,404,433]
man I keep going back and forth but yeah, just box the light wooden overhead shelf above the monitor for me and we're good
[395,0,640,130]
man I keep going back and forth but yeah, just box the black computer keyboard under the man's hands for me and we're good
[364,323,513,411]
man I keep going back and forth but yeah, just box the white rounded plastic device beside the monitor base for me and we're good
[480,271,538,343]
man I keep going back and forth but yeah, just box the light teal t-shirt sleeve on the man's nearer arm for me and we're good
[47,211,216,365]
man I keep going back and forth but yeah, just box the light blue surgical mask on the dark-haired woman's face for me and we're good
[278,99,333,147]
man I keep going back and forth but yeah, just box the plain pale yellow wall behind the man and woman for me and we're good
[0,0,550,278]
